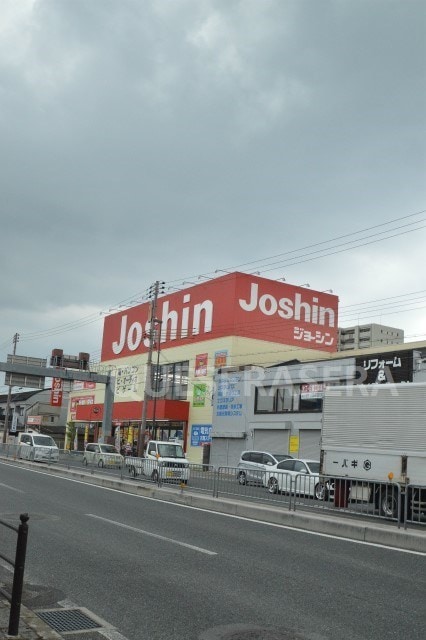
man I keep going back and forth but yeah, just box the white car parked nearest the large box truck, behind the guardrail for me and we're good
[266,458,334,500]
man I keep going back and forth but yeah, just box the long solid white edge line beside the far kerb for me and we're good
[0,460,426,557]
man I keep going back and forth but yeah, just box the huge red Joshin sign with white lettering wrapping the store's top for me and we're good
[101,272,338,361]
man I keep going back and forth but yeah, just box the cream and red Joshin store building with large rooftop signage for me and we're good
[68,272,338,462]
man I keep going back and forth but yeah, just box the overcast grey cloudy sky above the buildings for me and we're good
[0,0,426,380]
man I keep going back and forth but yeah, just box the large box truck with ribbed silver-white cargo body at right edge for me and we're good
[320,383,426,521]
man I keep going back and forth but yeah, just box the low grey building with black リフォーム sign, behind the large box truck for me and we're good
[210,342,426,467]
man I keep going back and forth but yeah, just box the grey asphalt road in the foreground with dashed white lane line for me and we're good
[0,462,426,640]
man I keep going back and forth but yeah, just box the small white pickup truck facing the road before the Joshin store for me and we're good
[124,440,189,484]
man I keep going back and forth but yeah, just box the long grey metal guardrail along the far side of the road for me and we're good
[0,445,426,528]
